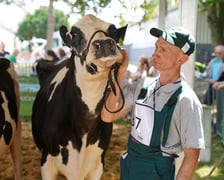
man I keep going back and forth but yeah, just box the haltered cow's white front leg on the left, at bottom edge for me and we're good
[41,155,58,180]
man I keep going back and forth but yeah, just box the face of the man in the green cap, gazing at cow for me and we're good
[151,38,183,72]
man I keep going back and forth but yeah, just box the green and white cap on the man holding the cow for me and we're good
[150,27,195,55]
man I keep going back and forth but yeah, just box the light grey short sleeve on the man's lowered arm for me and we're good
[179,89,205,149]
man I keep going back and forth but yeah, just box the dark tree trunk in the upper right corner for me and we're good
[199,0,224,46]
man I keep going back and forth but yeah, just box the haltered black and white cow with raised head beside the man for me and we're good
[32,15,127,180]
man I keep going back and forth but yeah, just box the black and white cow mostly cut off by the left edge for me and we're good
[0,58,21,180]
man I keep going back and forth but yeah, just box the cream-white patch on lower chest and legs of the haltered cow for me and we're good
[41,135,103,180]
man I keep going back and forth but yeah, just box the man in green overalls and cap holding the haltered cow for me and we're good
[101,27,205,180]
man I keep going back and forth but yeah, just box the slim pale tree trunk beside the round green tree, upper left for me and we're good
[46,0,55,49]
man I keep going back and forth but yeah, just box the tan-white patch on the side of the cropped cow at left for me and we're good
[0,91,16,155]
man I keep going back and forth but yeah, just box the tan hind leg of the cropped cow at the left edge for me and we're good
[10,120,22,180]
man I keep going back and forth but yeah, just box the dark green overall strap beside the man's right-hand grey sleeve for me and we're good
[162,86,182,146]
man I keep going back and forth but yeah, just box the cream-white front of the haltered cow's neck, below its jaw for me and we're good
[76,70,108,111]
